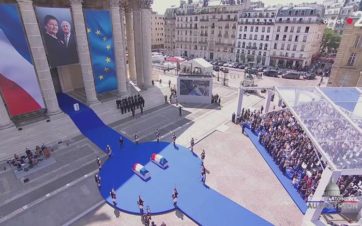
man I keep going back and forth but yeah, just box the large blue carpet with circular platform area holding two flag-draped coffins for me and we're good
[58,94,271,226]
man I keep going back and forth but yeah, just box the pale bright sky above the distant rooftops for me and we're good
[152,0,322,14]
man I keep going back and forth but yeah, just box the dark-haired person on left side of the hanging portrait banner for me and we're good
[43,15,65,67]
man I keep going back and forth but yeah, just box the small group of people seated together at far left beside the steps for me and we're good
[7,144,51,170]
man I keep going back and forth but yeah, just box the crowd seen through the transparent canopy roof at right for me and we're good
[294,100,362,169]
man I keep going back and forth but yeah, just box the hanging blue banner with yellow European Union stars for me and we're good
[84,9,117,93]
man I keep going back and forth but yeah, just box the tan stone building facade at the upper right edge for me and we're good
[328,17,362,87]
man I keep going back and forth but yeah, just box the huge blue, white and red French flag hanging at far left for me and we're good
[0,4,44,116]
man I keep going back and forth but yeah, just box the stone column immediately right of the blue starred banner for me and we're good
[110,0,128,96]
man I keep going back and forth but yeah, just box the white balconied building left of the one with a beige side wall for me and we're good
[235,8,278,65]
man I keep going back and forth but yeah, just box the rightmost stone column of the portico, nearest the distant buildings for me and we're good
[133,0,152,88]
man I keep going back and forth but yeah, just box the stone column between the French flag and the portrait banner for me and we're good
[18,0,61,116]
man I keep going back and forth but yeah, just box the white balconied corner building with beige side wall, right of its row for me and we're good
[270,4,326,69]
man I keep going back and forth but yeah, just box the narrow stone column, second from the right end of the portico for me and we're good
[126,0,137,82]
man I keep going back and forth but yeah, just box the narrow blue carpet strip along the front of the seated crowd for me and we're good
[245,128,307,214]
